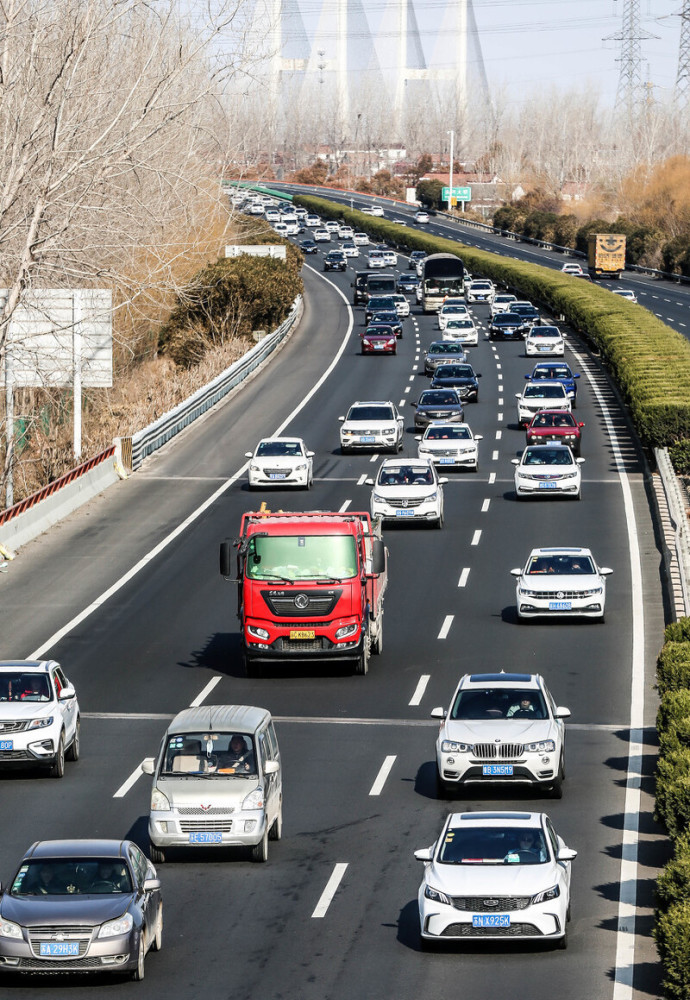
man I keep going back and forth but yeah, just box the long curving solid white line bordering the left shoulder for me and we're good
[27,265,354,660]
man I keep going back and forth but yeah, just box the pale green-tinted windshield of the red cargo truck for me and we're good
[247,535,357,582]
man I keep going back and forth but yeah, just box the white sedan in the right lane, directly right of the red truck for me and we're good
[510,547,613,621]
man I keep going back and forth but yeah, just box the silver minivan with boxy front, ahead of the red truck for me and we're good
[142,705,283,864]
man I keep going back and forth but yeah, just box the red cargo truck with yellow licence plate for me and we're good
[220,511,388,676]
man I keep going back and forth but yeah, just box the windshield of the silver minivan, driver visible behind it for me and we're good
[159,731,257,779]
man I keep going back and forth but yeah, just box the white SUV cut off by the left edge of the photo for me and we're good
[0,660,80,778]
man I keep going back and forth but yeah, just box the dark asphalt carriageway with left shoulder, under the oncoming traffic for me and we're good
[0,236,665,1000]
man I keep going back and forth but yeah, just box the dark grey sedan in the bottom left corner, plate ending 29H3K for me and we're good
[0,840,163,979]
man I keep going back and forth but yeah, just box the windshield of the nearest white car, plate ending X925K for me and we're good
[437,826,548,865]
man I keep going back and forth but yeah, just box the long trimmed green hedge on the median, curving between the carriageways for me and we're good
[294,195,690,448]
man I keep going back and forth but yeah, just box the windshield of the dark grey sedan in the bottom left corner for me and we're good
[10,858,133,896]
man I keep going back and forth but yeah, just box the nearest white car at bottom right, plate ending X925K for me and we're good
[414,810,577,948]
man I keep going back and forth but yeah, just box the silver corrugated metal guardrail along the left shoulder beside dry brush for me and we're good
[122,295,303,471]
